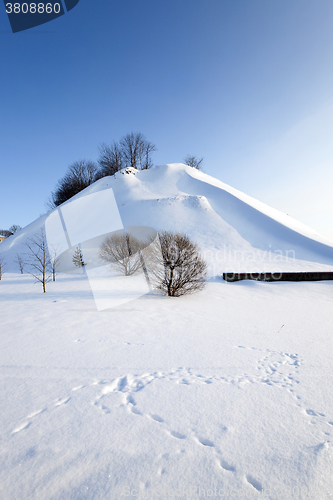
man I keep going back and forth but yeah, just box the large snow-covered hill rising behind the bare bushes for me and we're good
[0,164,333,275]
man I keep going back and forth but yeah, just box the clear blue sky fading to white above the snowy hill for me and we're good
[0,0,333,239]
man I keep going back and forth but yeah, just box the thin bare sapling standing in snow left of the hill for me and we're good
[26,229,52,293]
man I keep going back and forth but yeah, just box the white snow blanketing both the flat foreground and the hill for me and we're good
[0,165,333,500]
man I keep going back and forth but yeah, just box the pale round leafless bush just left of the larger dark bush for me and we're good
[99,232,146,276]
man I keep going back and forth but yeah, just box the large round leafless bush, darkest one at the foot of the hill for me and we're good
[145,231,207,297]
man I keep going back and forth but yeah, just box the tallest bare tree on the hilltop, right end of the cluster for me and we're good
[120,132,156,169]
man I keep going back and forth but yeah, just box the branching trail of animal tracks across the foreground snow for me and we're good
[12,343,333,492]
